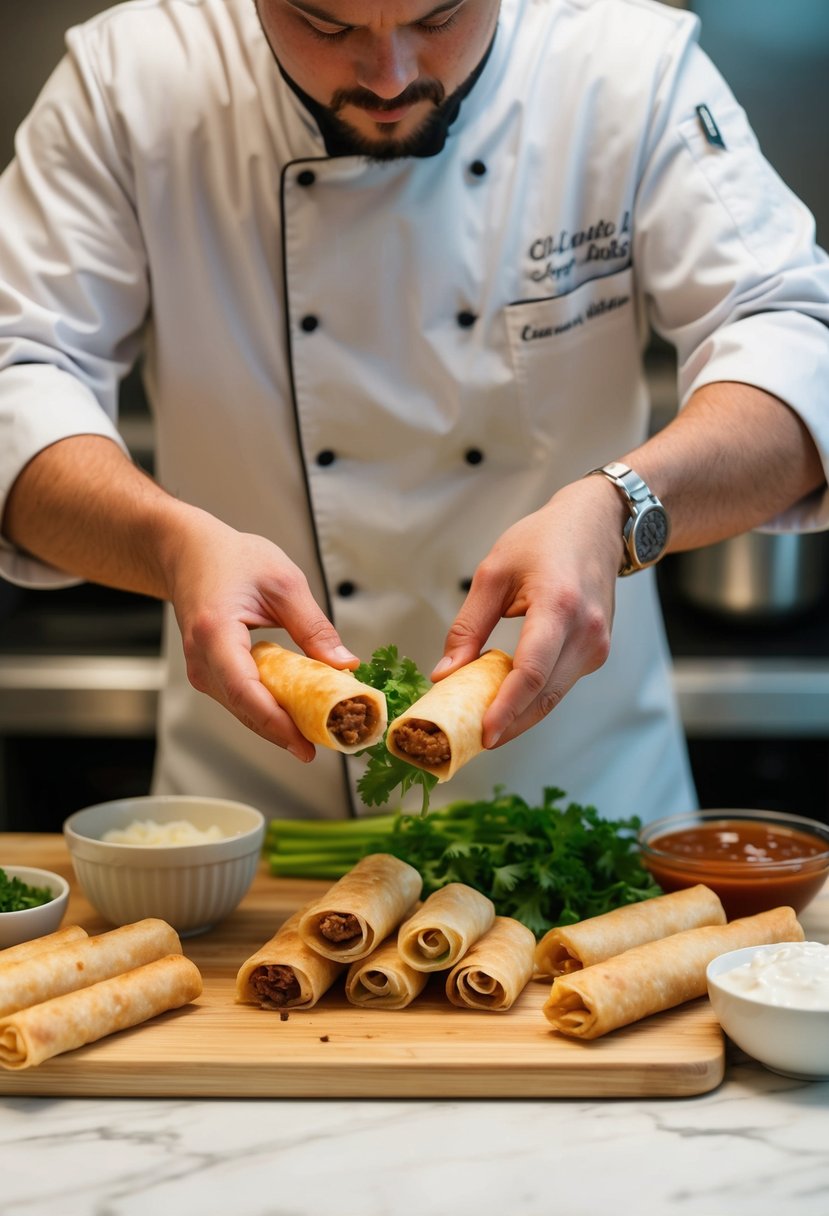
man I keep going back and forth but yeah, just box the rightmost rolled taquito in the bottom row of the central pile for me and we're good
[446,916,535,1013]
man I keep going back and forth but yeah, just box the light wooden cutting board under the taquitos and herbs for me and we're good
[0,834,724,1099]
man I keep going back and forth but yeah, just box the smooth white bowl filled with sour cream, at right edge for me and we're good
[706,941,829,1081]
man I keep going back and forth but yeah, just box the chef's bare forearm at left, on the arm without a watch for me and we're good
[2,435,209,599]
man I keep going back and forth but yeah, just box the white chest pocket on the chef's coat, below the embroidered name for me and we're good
[506,266,641,449]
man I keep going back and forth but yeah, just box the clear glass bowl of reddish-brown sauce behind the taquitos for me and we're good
[639,810,829,921]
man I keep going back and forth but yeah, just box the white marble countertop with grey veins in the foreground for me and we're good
[0,893,829,1216]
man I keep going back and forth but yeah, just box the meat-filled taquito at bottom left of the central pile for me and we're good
[236,903,345,1009]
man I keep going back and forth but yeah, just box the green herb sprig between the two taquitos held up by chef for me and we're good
[354,646,438,815]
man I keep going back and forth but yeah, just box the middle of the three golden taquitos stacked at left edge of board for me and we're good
[0,919,181,1018]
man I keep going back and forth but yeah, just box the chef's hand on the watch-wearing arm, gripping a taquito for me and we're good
[432,477,625,748]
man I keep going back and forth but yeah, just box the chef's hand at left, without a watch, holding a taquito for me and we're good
[168,516,359,762]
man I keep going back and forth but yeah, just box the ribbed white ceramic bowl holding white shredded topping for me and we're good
[63,795,265,936]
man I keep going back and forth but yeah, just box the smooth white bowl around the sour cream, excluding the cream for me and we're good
[706,946,829,1081]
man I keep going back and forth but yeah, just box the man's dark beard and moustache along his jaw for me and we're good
[271,35,495,161]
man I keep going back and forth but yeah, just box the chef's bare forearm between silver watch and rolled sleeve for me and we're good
[621,383,825,551]
